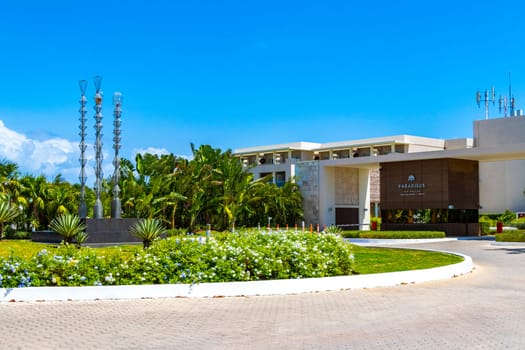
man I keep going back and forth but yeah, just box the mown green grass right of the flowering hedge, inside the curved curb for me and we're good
[354,246,463,274]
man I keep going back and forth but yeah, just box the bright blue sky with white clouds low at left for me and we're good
[0,0,525,183]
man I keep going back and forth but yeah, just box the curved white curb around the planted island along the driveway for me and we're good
[0,252,474,302]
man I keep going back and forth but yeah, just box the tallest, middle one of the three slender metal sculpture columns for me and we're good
[93,75,104,219]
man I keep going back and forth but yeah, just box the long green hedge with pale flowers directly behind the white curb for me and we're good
[0,232,353,288]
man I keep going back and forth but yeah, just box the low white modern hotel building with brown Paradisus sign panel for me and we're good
[234,116,525,234]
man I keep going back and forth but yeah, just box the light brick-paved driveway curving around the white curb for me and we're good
[0,241,525,349]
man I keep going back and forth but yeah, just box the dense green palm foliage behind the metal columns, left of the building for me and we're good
[0,145,303,237]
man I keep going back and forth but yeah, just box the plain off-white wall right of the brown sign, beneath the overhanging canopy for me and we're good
[479,160,525,213]
